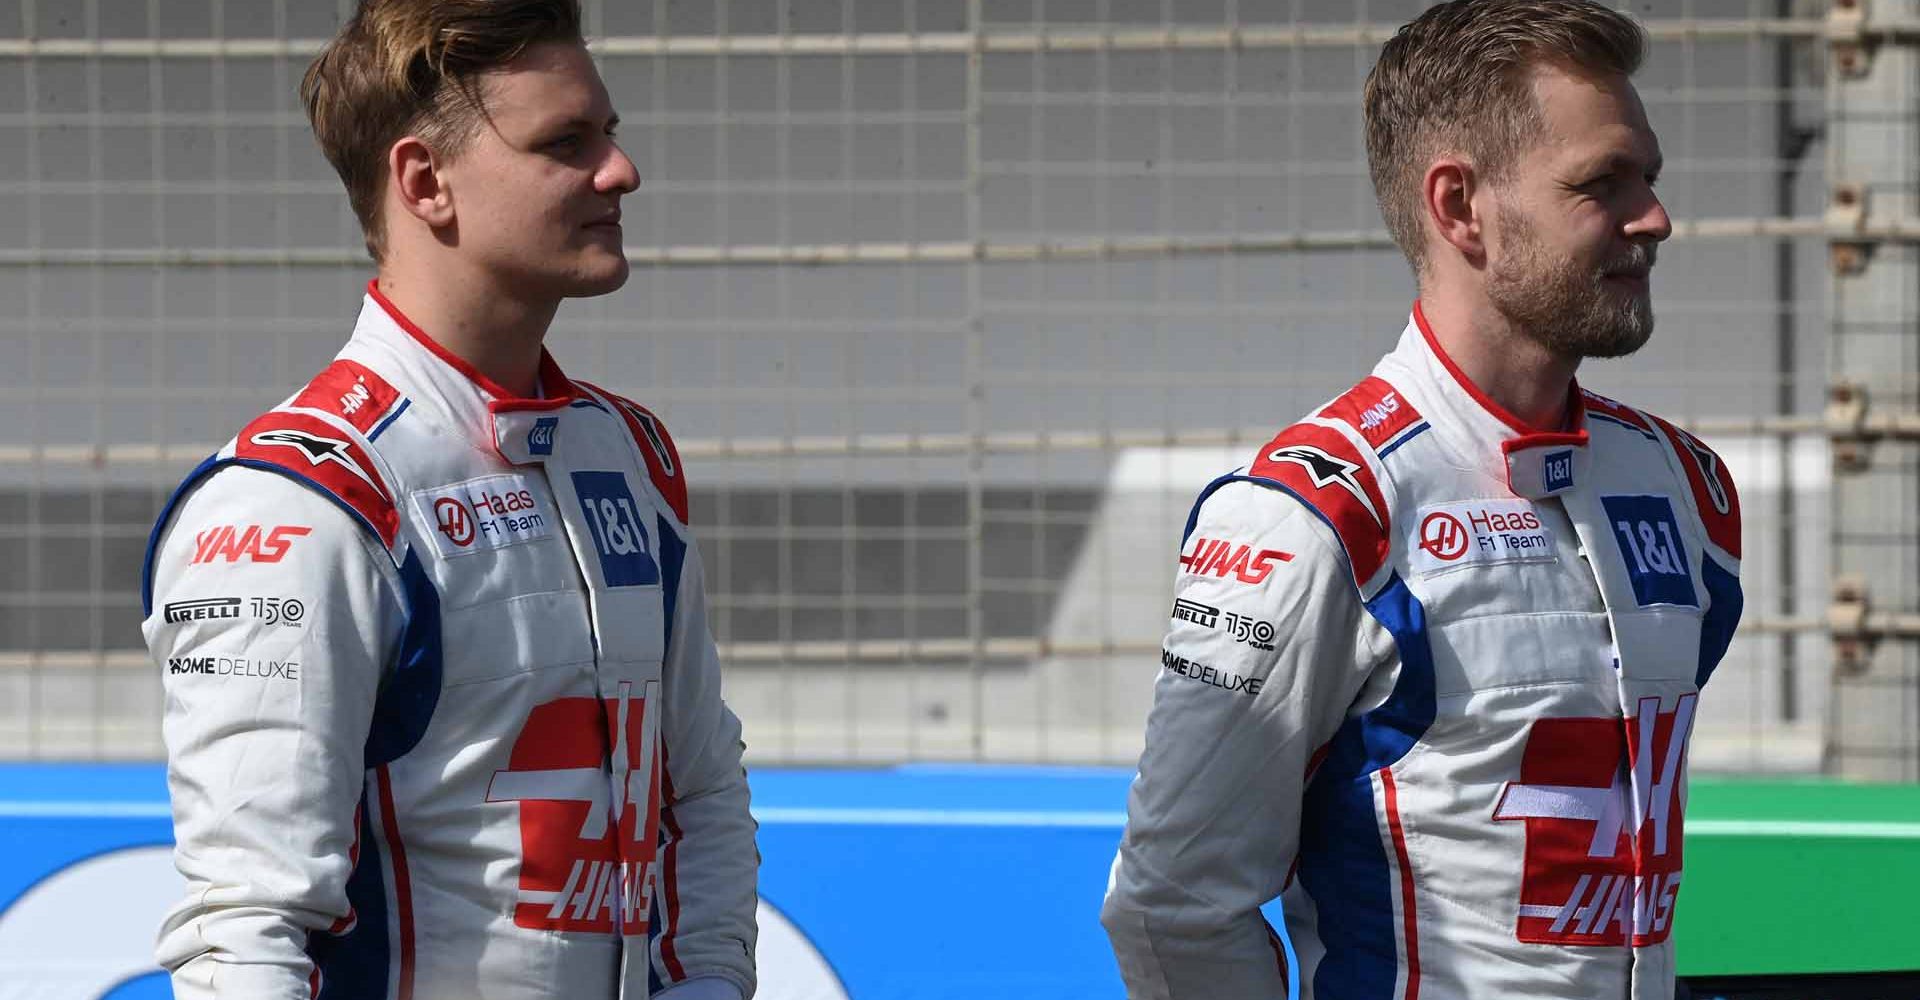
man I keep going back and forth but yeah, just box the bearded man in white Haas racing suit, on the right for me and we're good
[1102,0,1741,1000]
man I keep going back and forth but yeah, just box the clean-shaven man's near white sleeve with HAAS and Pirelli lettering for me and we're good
[142,466,401,1000]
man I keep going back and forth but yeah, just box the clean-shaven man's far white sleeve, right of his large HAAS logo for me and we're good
[653,534,760,996]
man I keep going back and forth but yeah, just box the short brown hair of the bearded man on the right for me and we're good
[1365,0,1645,273]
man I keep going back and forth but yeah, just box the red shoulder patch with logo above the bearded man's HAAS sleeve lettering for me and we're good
[1250,424,1390,583]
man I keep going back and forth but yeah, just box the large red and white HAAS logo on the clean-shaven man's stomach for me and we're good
[486,681,660,935]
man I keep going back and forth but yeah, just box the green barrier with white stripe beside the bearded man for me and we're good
[1674,777,1920,977]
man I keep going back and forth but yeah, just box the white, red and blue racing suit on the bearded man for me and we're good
[1102,305,1741,1000]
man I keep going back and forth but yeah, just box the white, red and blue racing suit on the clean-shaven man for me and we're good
[144,290,758,1000]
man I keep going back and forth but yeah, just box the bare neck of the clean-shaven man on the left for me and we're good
[380,263,559,397]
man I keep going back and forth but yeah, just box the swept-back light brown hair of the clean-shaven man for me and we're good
[300,0,582,261]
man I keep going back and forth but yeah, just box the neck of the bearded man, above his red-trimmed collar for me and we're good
[1421,288,1580,430]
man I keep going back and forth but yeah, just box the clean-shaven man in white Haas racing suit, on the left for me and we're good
[142,0,758,1000]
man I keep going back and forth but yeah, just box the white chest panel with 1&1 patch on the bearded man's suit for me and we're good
[1396,449,1699,702]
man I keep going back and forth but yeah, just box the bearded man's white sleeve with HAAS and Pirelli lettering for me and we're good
[1100,482,1384,1000]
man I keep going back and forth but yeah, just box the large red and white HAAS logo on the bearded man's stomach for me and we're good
[1494,695,1697,948]
